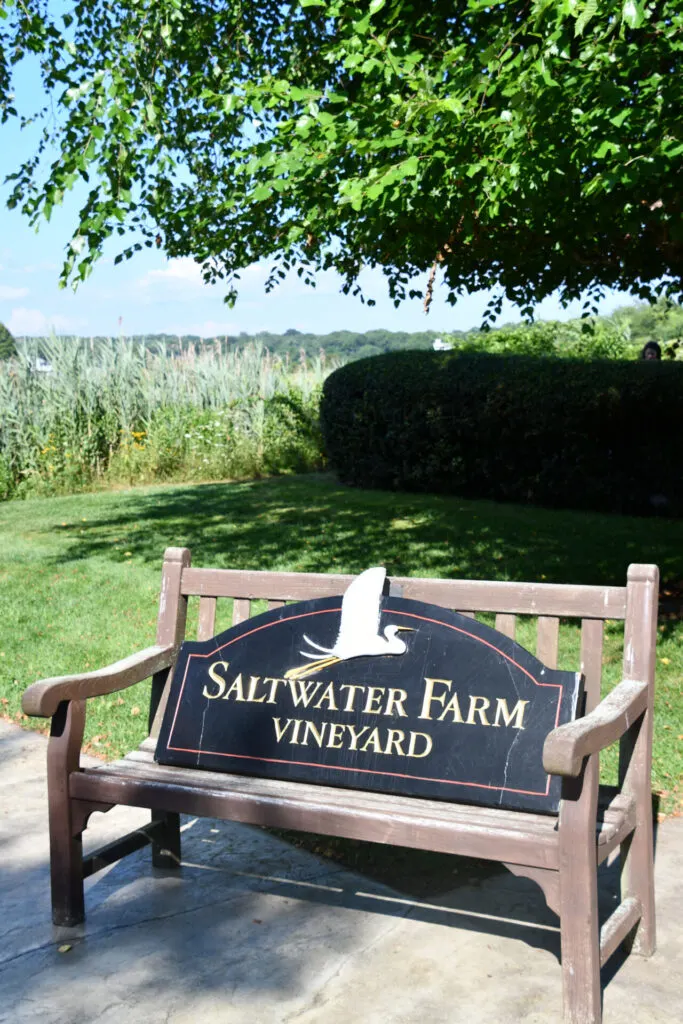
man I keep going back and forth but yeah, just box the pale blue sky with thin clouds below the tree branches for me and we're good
[0,43,632,337]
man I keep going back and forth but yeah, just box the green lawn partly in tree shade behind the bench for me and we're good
[0,475,683,813]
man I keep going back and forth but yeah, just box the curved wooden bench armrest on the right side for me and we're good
[543,679,648,775]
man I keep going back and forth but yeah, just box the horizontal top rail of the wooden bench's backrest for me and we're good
[182,568,626,618]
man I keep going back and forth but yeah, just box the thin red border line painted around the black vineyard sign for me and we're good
[167,605,564,797]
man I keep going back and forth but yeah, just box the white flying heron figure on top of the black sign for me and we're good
[285,566,415,679]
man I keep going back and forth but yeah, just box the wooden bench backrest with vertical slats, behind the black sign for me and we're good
[152,548,658,735]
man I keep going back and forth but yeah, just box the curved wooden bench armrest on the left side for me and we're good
[22,644,177,718]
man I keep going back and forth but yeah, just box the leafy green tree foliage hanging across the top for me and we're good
[0,0,683,315]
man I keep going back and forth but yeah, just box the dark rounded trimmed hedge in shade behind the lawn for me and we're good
[321,351,683,516]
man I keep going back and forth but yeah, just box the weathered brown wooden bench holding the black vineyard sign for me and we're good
[24,548,658,1024]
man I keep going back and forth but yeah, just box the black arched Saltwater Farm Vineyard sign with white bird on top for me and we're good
[156,568,582,812]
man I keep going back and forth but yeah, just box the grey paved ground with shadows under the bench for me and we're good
[0,723,683,1024]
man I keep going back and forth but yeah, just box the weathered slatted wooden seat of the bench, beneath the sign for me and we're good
[69,743,635,870]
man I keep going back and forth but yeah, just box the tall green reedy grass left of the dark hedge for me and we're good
[0,337,334,498]
